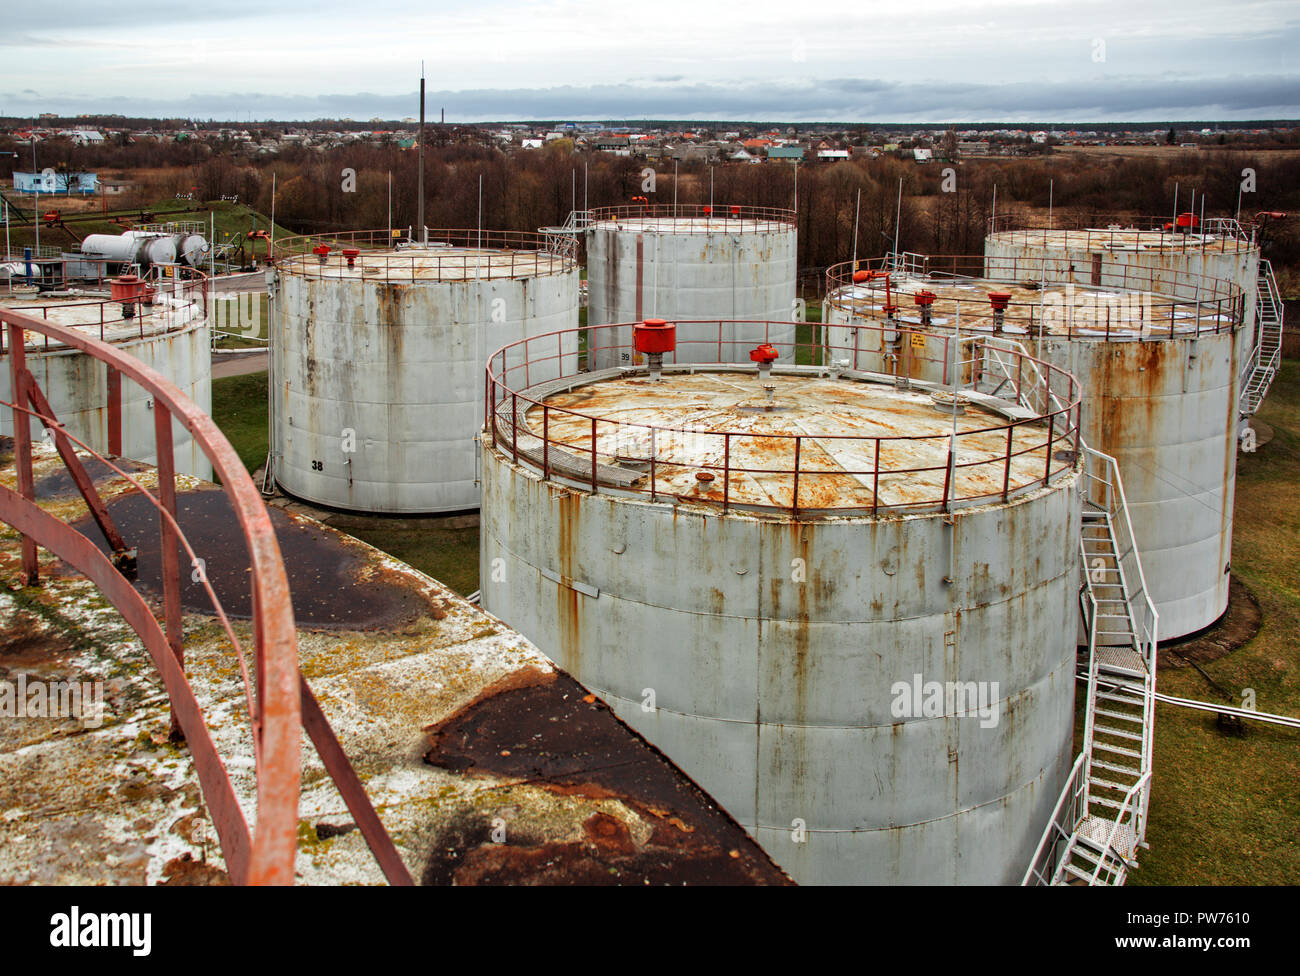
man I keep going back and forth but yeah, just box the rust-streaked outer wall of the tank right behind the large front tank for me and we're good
[824,278,1244,639]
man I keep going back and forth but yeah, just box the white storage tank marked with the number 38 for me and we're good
[270,230,579,513]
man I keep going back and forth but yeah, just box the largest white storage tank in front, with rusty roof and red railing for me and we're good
[480,322,1080,884]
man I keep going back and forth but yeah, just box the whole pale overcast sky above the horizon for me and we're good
[0,0,1300,122]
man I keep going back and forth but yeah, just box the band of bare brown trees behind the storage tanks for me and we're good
[10,127,1300,280]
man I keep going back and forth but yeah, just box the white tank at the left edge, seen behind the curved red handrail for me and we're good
[0,276,212,481]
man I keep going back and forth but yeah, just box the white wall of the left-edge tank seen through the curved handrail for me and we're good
[0,303,212,481]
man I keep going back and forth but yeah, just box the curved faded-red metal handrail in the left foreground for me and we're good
[0,308,302,884]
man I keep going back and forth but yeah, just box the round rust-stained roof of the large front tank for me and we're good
[525,369,1071,509]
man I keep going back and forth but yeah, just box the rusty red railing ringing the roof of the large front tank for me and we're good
[484,320,1082,516]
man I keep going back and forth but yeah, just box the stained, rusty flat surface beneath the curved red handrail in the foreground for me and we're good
[0,443,788,885]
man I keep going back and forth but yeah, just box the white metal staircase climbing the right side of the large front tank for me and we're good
[1023,447,1158,885]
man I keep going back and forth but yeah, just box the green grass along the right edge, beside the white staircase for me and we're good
[1130,360,1300,885]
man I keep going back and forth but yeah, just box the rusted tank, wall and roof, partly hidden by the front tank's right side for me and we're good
[826,256,1244,638]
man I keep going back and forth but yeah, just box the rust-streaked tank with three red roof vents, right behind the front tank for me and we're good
[823,256,1243,643]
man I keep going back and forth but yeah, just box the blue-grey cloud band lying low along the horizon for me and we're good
[0,74,1300,122]
